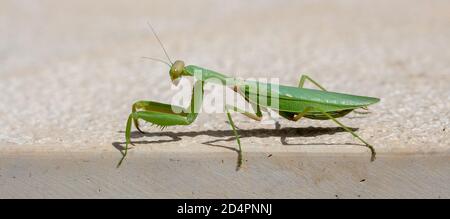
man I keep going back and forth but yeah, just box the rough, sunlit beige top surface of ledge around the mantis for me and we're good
[0,0,450,198]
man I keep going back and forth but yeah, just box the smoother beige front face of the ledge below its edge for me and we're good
[0,152,450,198]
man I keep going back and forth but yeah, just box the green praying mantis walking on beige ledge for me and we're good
[117,24,380,169]
